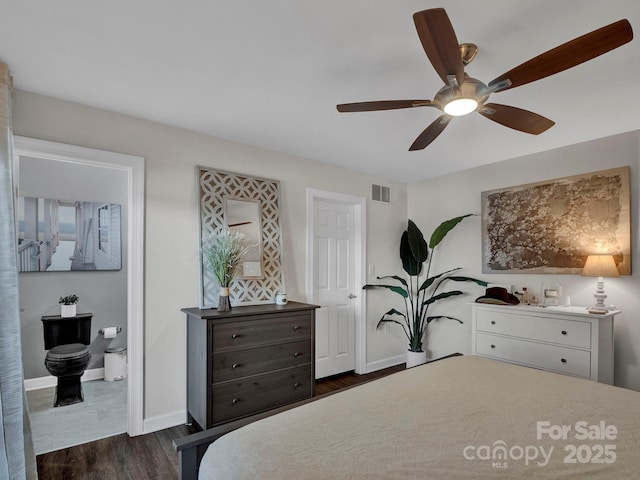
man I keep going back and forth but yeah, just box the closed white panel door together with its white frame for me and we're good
[307,188,366,378]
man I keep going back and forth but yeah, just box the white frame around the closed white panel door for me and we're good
[306,187,367,374]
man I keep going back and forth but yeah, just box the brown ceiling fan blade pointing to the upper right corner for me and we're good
[489,19,633,92]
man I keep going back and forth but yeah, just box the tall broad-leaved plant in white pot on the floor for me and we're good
[363,214,487,367]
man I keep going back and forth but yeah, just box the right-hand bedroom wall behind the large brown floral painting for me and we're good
[408,132,640,390]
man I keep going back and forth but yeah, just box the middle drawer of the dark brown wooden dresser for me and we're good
[212,339,311,383]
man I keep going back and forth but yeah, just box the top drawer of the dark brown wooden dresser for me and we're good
[212,314,312,352]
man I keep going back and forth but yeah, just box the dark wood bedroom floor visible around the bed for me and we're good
[37,364,404,480]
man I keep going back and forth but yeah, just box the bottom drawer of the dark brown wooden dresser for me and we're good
[212,365,313,424]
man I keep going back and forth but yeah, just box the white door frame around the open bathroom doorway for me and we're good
[13,135,145,437]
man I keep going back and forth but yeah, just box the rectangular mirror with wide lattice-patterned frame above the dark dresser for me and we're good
[196,166,284,308]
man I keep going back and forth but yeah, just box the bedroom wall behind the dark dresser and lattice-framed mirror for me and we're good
[13,91,407,419]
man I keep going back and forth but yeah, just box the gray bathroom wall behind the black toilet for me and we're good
[18,157,128,379]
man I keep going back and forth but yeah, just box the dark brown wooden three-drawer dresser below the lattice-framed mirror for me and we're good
[182,302,318,429]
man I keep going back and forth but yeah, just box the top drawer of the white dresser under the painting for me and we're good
[476,310,591,348]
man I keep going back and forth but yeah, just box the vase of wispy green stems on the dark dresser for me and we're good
[202,230,250,312]
